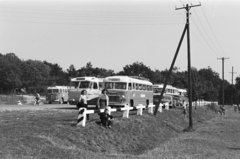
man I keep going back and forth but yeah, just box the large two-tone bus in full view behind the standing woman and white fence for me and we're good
[104,76,153,107]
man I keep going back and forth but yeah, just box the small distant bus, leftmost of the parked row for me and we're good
[46,86,68,104]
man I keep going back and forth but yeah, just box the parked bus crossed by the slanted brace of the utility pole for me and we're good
[153,84,180,108]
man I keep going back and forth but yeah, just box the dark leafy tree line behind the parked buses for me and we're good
[0,53,240,104]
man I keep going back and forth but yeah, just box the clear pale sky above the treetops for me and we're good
[0,0,240,83]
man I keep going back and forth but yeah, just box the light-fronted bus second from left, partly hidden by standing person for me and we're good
[68,77,103,106]
